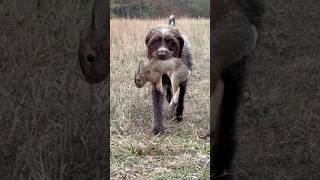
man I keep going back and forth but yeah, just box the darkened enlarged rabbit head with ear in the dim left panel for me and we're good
[78,0,110,84]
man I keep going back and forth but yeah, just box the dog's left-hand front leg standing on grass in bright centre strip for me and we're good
[152,84,163,135]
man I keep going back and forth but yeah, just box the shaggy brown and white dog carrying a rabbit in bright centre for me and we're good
[136,25,192,134]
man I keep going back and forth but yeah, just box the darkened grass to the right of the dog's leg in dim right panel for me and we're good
[211,0,320,179]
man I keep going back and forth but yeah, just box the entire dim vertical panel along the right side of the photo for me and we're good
[210,0,320,179]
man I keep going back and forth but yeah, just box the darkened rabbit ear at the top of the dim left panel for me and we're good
[92,0,108,37]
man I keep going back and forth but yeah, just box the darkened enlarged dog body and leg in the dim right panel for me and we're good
[210,0,263,179]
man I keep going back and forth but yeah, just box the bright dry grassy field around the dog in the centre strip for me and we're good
[110,19,210,179]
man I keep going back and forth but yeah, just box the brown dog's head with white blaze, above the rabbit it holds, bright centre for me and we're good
[145,25,184,60]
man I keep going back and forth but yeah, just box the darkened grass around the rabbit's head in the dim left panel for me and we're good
[0,0,110,180]
